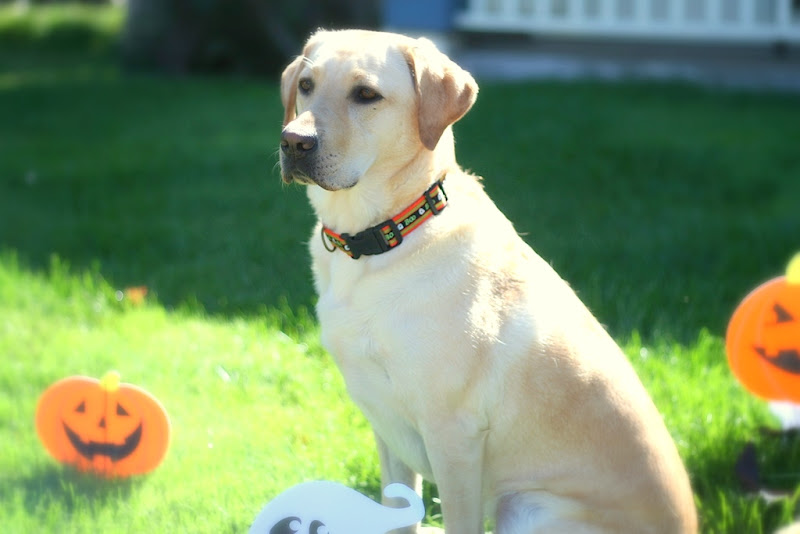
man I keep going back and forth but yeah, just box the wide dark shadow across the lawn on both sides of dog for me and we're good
[0,49,800,348]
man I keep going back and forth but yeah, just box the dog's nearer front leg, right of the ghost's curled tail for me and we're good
[425,419,487,534]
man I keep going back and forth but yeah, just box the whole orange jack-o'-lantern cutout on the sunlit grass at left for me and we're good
[36,372,170,477]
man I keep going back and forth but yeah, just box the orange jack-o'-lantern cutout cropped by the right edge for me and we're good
[725,254,800,403]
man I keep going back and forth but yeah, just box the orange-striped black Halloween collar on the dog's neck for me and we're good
[322,178,447,260]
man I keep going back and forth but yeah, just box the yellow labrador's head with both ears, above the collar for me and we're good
[281,30,478,191]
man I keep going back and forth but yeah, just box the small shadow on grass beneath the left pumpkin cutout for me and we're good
[0,465,141,515]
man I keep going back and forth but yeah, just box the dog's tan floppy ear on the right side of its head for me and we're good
[404,38,478,150]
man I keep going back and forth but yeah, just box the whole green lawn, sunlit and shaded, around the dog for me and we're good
[0,8,800,533]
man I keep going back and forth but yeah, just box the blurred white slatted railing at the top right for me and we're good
[456,0,800,43]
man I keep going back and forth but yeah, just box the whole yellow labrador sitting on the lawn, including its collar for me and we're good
[281,30,697,534]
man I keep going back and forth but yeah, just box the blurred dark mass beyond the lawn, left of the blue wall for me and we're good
[122,0,378,74]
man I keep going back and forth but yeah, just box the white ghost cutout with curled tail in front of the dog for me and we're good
[249,481,425,534]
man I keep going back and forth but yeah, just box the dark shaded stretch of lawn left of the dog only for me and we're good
[0,54,314,322]
